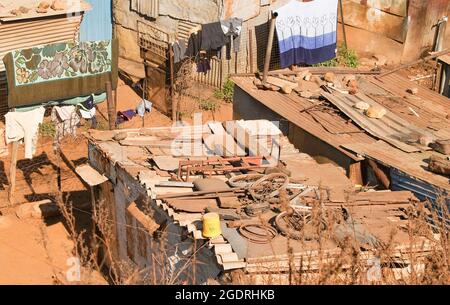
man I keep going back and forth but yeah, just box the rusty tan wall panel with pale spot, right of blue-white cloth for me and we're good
[342,0,408,42]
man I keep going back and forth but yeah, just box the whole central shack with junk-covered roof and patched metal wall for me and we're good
[85,121,432,284]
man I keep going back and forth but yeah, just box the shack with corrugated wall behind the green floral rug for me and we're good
[0,0,91,116]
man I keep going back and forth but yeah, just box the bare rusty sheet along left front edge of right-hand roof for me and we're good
[232,76,376,161]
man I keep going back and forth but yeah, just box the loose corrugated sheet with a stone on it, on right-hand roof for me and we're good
[322,92,434,152]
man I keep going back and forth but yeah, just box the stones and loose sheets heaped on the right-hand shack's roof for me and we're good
[253,68,450,175]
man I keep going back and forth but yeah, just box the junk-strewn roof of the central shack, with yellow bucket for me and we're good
[85,120,440,280]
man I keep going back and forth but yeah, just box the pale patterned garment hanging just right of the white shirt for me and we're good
[51,106,80,150]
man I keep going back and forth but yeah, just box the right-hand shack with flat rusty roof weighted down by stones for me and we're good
[232,68,450,218]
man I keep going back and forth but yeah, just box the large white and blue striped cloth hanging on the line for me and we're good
[276,0,338,68]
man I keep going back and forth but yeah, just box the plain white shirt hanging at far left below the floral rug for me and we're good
[5,107,45,159]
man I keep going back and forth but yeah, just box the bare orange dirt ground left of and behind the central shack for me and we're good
[0,77,232,284]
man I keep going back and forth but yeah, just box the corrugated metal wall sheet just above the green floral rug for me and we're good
[0,15,82,71]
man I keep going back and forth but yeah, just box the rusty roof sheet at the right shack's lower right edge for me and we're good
[343,141,450,192]
